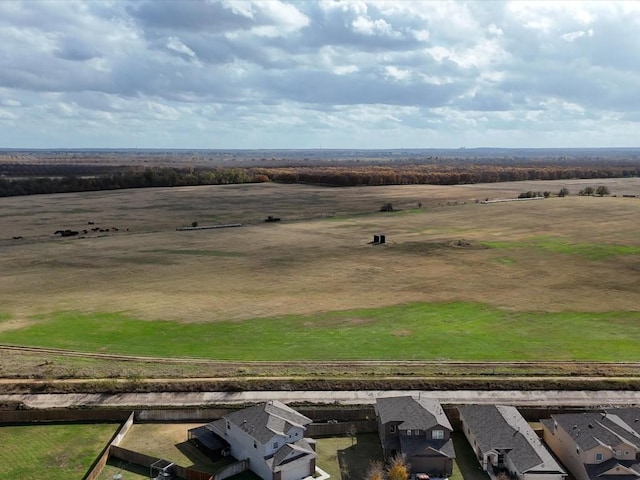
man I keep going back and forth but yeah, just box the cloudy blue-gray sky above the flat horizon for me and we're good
[0,0,640,149]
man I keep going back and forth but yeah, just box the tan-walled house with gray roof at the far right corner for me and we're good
[541,408,640,480]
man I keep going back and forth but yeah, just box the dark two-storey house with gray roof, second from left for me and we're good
[375,396,455,477]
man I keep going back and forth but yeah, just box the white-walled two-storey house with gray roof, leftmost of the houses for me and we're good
[191,400,316,480]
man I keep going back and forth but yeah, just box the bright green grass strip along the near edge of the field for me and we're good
[0,303,640,361]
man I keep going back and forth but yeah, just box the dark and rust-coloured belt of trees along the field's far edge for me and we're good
[0,160,640,197]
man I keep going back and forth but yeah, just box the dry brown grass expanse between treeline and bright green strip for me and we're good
[0,179,640,322]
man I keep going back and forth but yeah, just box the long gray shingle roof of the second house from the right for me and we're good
[459,405,564,473]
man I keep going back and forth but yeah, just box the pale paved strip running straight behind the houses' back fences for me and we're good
[0,390,640,409]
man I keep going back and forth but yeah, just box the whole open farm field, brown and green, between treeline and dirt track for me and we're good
[0,178,640,372]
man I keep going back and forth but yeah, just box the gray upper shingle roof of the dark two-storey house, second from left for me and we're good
[375,396,452,431]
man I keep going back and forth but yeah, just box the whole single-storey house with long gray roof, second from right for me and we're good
[458,405,567,480]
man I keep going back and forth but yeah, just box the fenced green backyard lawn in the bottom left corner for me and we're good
[0,424,119,480]
